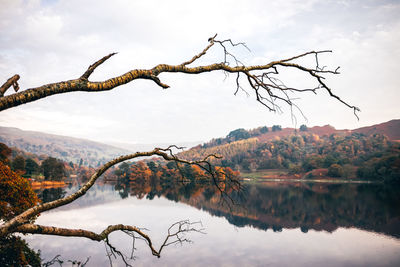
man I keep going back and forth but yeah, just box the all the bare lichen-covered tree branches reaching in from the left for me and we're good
[0,35,359,266]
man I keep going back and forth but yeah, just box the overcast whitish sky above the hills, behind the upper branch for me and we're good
[0,0,400,147]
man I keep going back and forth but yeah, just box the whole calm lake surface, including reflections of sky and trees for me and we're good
[24,182,400,266]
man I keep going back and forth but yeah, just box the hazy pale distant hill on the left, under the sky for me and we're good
[0,127,131,167]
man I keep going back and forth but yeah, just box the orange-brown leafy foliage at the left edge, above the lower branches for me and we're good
[0,161,39,220]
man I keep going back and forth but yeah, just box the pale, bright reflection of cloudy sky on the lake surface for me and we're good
[25,186,400,266]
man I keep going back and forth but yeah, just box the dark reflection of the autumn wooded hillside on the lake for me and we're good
[116,181,400,237]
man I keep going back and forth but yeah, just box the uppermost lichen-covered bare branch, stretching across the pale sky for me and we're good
[0,35,359,119]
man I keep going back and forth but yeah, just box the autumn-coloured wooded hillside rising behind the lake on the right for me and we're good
[179,120,400,179]
